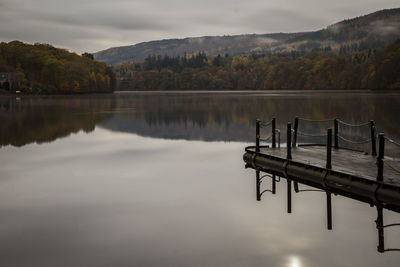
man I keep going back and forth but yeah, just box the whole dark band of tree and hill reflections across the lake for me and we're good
[0,92,400,146]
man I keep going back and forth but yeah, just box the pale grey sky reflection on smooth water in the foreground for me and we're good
[0,128,400,266]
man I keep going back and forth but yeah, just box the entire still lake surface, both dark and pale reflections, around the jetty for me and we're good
[0,92,400,267]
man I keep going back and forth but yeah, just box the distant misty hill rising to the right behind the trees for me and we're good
[94,8,400,64]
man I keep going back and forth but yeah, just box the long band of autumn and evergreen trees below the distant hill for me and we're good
[115,41,400,90]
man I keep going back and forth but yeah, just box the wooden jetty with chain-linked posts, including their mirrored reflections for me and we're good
[243,118,400,252]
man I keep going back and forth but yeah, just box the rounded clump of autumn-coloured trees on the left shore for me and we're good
[0,41,116,94]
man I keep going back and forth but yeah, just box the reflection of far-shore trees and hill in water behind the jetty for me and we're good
[106,93,400,141]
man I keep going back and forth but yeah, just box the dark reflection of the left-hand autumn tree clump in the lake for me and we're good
[0,95,113,146]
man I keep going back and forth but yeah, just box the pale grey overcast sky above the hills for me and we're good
[0,0,400,53]
